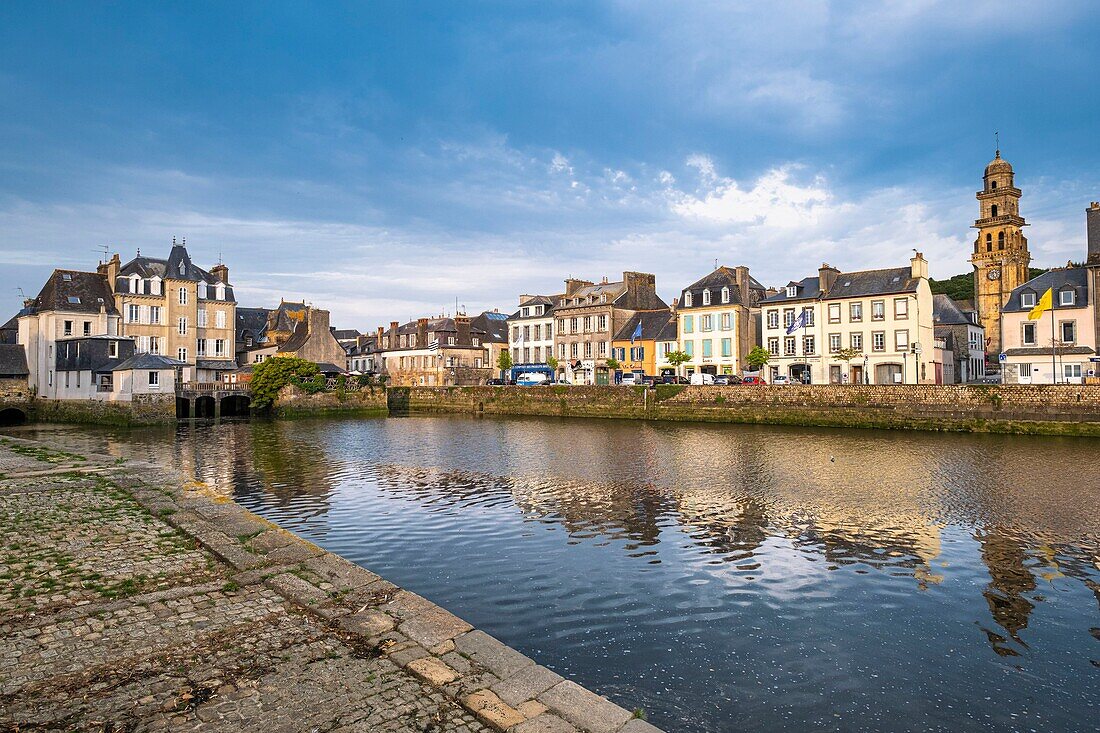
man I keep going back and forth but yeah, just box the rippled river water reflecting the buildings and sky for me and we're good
[10,417,1100,732]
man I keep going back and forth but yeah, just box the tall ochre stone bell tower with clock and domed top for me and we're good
[970,150,1031,360]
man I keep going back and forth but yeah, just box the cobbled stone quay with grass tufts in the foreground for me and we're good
[0,437,658,733]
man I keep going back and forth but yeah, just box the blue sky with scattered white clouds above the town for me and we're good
[0,0,1100,330]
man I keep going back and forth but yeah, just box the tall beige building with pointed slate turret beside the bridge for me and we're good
[99,241,237,382]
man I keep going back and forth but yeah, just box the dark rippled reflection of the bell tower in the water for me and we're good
[976,526,1035,657]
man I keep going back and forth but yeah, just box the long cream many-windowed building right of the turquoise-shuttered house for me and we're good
[765,253,936,384]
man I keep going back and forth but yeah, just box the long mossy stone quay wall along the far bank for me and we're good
[389,384,1100,436]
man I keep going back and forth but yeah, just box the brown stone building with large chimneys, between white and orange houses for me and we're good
[553,272,669,384]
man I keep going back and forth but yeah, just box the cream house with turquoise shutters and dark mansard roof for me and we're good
[677,266,766,374]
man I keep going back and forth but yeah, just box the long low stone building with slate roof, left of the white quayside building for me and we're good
[374,314,493,386]
